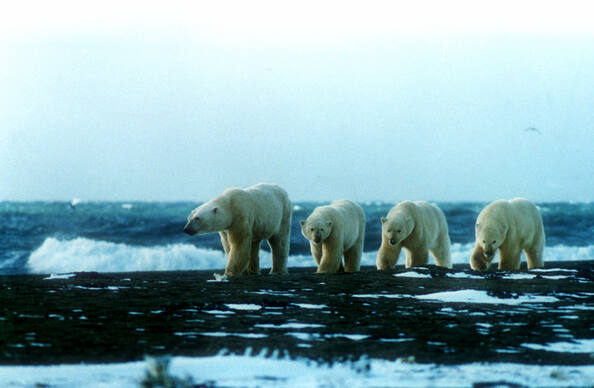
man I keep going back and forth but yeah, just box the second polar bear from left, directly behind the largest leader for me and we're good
[300,199,365,273]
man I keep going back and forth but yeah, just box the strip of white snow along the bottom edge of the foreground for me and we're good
[0,355,594,388]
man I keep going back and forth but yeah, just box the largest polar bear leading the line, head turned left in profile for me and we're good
[184,183,291,276]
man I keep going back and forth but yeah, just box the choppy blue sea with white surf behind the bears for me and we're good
[0,199,594,275]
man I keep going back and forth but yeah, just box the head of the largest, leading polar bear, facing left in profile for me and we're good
[184,199,232,236]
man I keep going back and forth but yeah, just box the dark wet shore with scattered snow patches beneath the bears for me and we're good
[0,261,594,365]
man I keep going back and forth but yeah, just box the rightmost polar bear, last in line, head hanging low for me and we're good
[470,198,545,271]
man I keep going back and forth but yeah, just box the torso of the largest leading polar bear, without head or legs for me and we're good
[222,183,291,240]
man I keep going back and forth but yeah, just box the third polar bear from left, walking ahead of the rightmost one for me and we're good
[376,201,452,269]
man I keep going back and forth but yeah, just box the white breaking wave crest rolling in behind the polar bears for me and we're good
[26,237,594,273]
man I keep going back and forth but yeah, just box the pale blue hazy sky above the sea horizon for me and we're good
[0,1,594,201]
